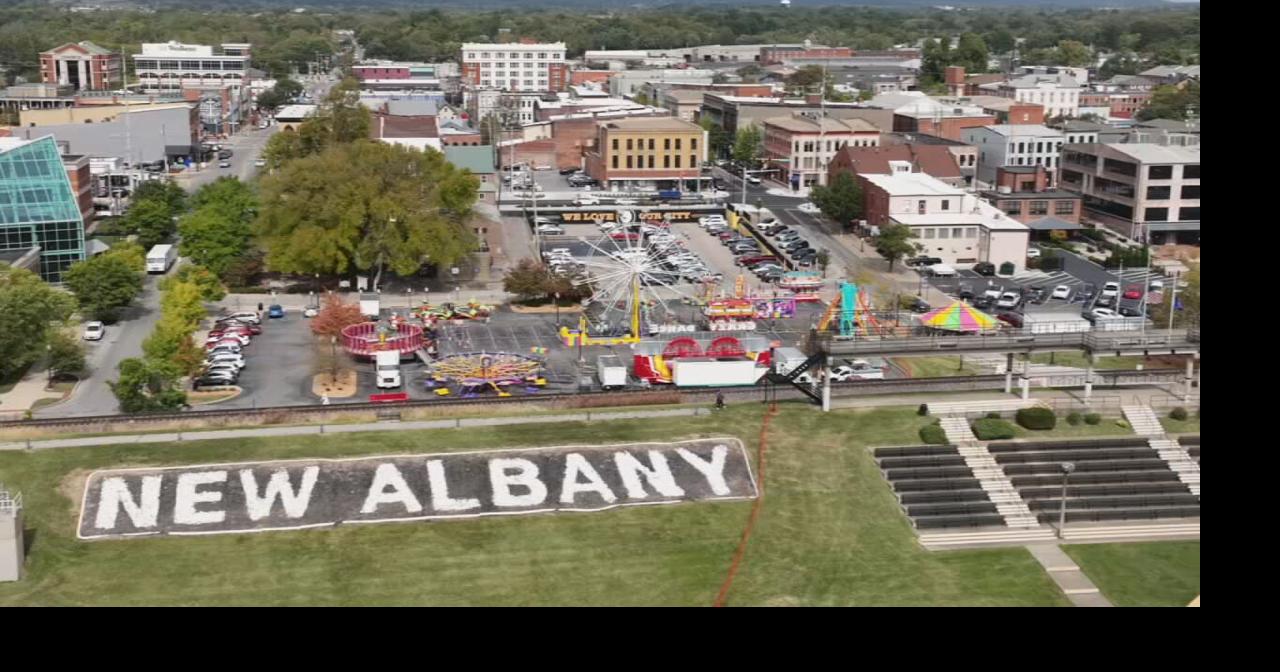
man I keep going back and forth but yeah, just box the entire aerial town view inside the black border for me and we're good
[0,0,1201,607]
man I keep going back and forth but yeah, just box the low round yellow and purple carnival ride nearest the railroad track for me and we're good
[426,352,547,398]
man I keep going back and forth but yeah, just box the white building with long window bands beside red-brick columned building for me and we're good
[133,41,250,92]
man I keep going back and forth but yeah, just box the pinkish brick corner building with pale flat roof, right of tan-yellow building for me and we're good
[763,114,879,188]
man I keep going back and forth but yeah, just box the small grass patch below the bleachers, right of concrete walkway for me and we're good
[1062,541,1199,607]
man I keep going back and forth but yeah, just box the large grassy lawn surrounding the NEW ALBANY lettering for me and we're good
[0,403,1066,605]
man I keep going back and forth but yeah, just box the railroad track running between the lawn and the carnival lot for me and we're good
[0,369,1183,429]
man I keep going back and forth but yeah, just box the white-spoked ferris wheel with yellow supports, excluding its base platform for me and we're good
[575,232,696,337]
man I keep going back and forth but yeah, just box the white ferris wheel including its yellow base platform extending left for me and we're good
[559,230,696,347]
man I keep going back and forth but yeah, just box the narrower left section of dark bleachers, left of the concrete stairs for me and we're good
[874,445,1005,530]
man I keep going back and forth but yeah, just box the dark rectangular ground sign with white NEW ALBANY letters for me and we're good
[78,438,758,539]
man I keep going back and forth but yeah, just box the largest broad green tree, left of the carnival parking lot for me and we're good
[257,141,479,284]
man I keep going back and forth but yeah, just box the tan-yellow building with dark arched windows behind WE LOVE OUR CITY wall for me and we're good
[585,116,707,188]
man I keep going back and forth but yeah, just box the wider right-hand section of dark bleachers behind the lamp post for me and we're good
[987,436,1199,524]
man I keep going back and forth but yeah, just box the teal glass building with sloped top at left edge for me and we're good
[0,136,84,283]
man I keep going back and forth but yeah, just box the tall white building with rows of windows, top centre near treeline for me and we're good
[462,41,568,91]
